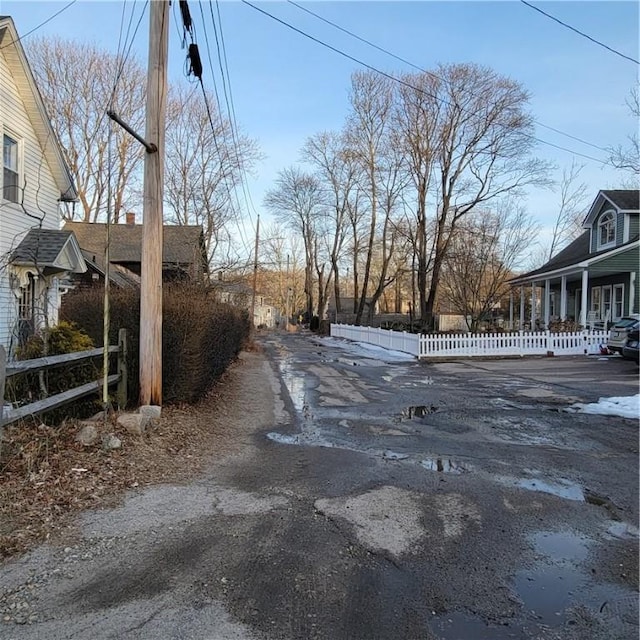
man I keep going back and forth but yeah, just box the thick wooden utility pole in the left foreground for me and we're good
[140,0,169,405]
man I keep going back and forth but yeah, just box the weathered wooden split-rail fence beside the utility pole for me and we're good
[0,329,127,429]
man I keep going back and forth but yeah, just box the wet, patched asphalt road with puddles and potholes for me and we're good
[0,333,639,640]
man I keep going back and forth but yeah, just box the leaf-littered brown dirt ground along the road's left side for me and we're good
[0,353,260,559]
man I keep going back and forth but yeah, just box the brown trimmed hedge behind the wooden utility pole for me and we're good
[60,283,250,404]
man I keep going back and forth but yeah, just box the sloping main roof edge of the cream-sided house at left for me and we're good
[0,16,78,202]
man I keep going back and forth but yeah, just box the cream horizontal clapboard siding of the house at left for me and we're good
[0,41,60,347]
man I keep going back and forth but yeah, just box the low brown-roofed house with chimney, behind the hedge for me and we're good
[64,213,207,287]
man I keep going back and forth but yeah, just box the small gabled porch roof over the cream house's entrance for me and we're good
[9,229,87,273]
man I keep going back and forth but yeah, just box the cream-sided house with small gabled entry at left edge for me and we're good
[0,16,86,355]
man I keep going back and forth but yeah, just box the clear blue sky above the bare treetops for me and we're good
[0,0,640,258]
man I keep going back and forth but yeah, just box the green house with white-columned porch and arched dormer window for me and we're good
[511,190,640,327]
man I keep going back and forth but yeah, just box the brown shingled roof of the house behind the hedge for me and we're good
[64,222,204,265]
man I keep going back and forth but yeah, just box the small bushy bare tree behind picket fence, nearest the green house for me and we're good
[443,202,537,332]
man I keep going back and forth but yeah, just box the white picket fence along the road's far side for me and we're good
[331,324,608,358]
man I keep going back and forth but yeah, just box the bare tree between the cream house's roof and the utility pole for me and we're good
[25,38,146,222]
